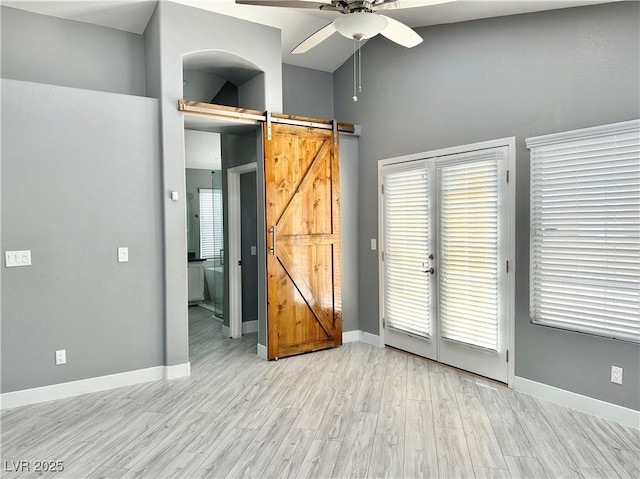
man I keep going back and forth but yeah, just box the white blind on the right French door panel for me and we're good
[438,159,500,351]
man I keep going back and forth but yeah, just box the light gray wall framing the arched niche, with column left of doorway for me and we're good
[145,2,282,365]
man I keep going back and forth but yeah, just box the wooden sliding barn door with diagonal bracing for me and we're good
[264,123,342,359]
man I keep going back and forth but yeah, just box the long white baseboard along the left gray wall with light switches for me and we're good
[0,363,191,409]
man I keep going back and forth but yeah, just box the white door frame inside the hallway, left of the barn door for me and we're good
[227,162,258,338]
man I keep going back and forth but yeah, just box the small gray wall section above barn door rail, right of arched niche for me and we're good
[282,64,334,120]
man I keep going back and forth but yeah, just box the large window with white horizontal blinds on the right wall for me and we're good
[527,120,640,342]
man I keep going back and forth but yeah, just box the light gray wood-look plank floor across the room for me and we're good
[2,307,640,478]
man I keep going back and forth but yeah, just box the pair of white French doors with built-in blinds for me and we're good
[380,146,509,382]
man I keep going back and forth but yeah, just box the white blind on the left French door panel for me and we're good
[384,162,431,338]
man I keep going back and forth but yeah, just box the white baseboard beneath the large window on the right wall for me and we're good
[514,376,640,429]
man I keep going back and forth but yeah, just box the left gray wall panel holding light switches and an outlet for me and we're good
[0,80,164,393]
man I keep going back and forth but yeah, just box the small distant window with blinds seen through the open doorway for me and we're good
[198,188,223,259]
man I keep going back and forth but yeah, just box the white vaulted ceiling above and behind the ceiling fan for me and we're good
[2,0,627,72]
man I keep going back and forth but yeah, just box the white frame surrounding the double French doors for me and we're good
[378,137,516,387]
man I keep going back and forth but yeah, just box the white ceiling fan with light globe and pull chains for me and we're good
[236,0,422,53]
